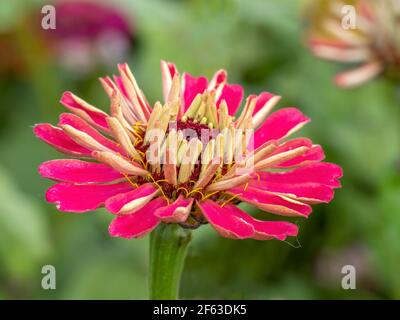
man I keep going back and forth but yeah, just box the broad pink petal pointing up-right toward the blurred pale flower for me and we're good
[254,108,310,148]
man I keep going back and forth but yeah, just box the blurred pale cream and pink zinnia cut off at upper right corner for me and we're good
[308,0,400,87]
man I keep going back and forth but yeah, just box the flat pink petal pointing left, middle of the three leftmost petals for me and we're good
[39,159,124,183]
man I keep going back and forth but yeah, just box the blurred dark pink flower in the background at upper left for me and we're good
[43,0,134,73]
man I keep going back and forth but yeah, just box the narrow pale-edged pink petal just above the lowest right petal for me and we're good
[227,187,312,217]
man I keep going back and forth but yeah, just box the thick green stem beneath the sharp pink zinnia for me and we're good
[149,223,191,300]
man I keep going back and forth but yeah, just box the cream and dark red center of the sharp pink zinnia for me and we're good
[125,114,246,228]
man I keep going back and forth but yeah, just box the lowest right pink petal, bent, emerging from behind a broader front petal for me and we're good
[225,204,298,240]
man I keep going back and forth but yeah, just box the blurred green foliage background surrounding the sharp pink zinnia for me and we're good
[0,0,400,299]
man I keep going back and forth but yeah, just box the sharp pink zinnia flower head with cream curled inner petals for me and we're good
[34,61,342,240]
